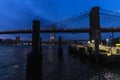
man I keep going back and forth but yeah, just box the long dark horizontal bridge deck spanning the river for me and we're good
[0,28,120,34]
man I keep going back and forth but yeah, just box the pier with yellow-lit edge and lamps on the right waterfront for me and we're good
[69,43,120,63]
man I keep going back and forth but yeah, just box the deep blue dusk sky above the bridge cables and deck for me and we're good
[0,0,120,39]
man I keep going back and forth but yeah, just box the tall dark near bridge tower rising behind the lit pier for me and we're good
[89,7,101,40]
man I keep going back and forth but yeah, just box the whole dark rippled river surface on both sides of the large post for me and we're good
[0,45,120,80]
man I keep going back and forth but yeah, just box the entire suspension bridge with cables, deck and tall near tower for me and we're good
[0,7,120,40]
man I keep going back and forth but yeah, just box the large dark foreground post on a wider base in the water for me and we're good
[26,20,42,80]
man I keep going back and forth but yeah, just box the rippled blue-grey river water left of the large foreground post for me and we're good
[0,45,30,80]
